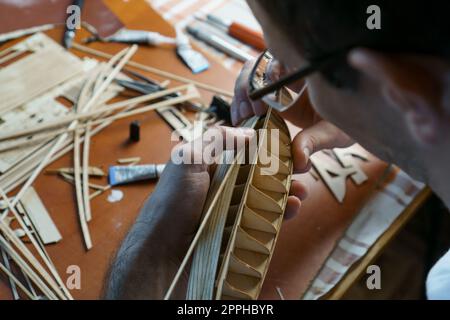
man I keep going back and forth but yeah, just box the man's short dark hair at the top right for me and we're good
[258,0,450,88]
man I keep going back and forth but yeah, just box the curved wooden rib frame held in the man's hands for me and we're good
[178,111,293,300]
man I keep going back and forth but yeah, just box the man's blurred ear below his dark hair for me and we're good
[349,49,450,145]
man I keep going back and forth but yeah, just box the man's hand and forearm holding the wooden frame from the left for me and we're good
[105,127,307,299]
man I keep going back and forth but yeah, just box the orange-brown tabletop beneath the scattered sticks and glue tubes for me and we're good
[0,0,430,299]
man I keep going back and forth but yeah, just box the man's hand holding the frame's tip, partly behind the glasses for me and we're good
[231,61,353,173]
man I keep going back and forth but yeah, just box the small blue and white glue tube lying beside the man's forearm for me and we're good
[109,164,166,186]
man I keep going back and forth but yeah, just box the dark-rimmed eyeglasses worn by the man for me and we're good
[249,50,348,112]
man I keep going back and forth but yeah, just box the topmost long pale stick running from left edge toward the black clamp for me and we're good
[0,85,193,141]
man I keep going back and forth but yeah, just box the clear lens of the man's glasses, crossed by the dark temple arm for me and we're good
[251,51,305,112]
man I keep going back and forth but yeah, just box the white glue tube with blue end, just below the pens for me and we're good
[177,30,209,74]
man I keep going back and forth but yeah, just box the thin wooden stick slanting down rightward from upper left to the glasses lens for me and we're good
[72,43,234,98]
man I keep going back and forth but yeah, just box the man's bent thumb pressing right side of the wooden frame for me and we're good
[292,120,354,173]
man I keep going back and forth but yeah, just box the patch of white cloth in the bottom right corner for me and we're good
[427,250,450,300]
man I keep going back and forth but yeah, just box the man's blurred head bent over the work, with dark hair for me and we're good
[248,0,450,179]
